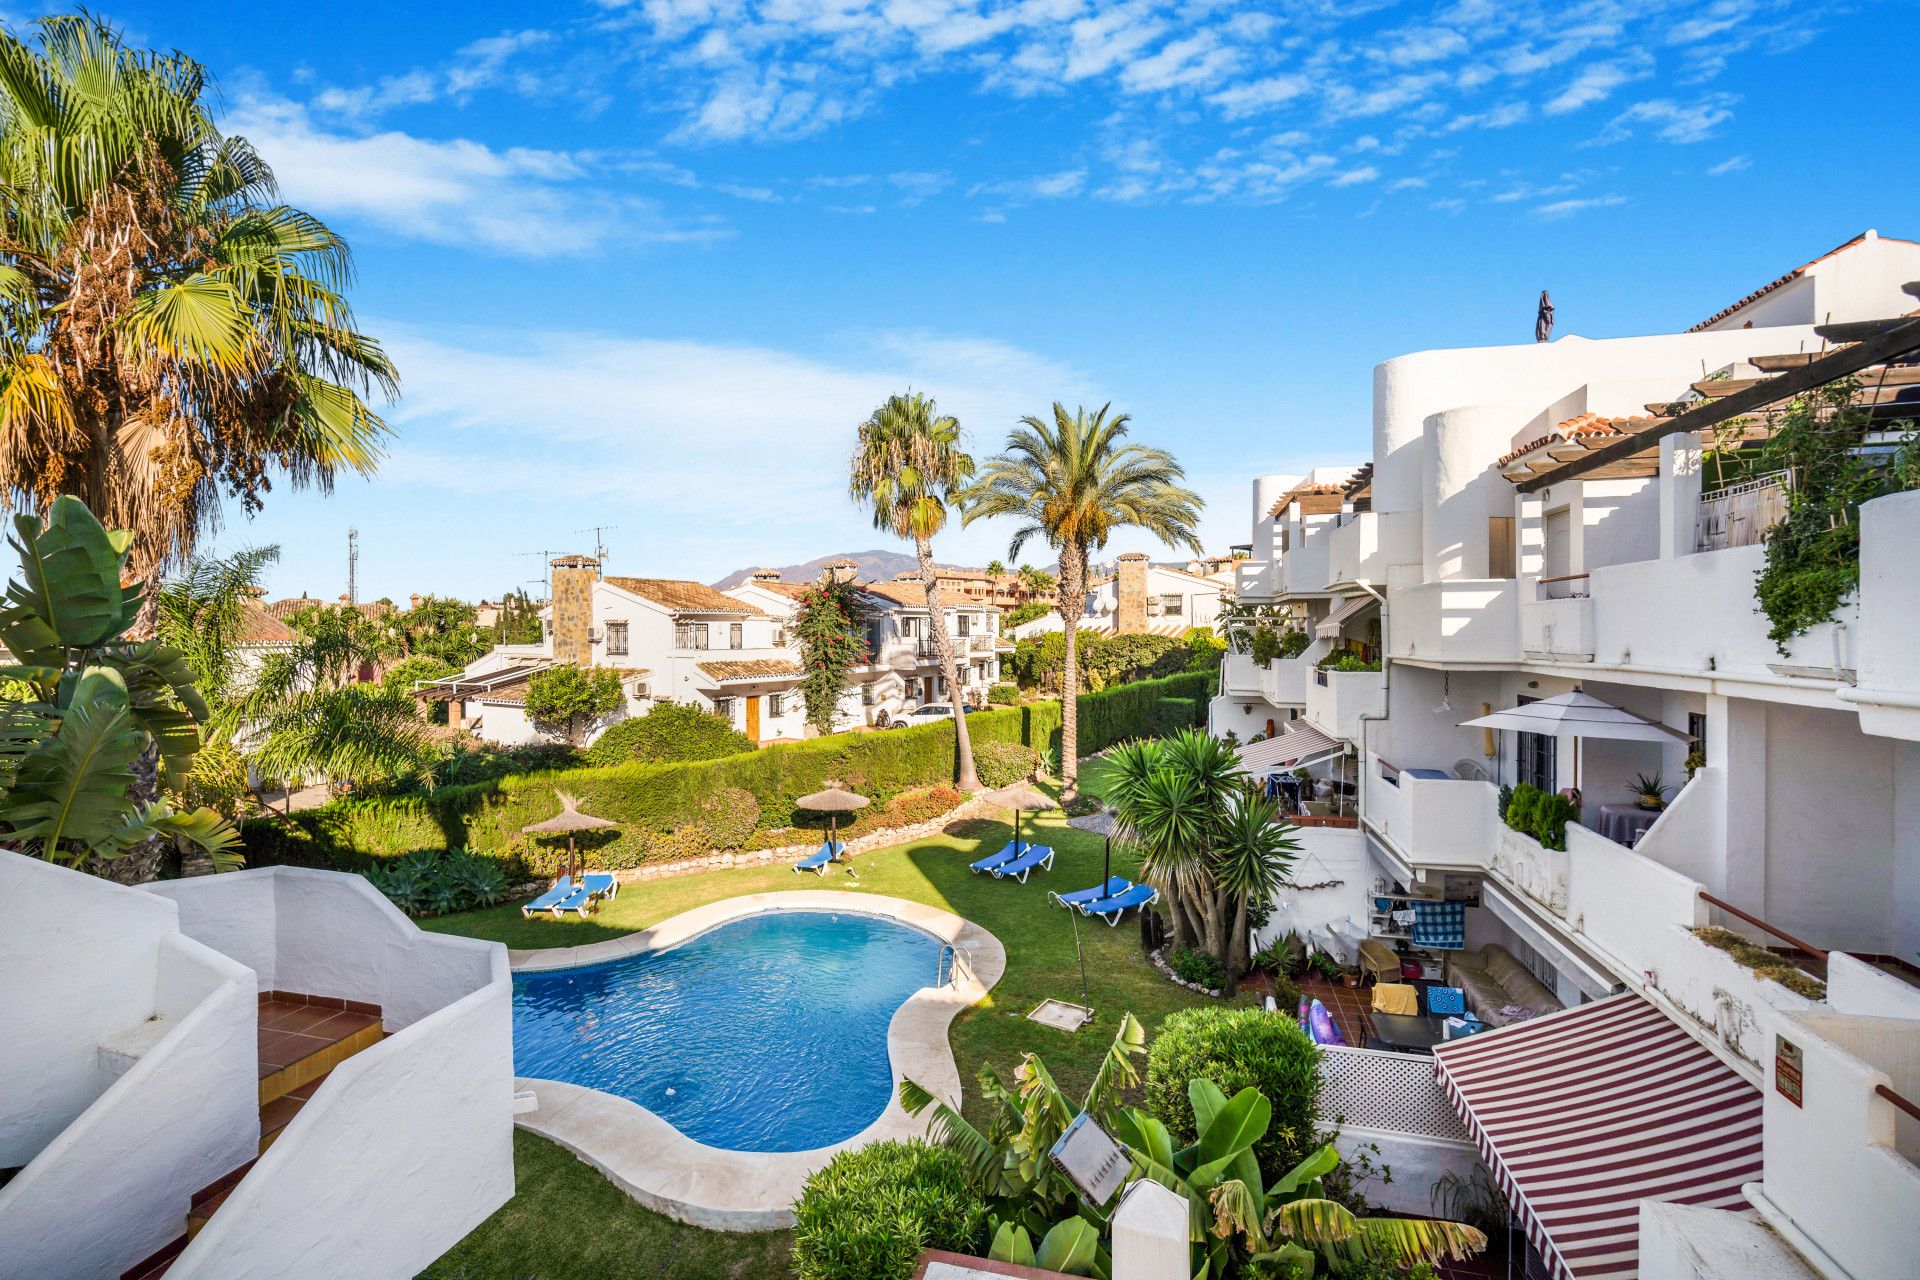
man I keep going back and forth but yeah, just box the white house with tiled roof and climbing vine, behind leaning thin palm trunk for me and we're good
[728,560,1012,731]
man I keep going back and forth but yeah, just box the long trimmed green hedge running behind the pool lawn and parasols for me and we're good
[242,674,1210,869]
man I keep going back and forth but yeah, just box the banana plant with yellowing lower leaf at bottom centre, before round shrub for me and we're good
[1117,1080,1486,1280]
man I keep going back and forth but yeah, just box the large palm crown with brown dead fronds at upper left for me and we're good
[0,15,397,576]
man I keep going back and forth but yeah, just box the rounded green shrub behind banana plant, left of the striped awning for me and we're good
[1146,1007,1321,1180]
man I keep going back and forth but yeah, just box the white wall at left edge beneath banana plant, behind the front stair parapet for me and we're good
[0,852,179,1167]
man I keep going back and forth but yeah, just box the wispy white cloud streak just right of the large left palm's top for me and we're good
[225,98,728,257]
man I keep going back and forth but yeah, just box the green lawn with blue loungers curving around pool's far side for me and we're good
[420,790,1254,1117]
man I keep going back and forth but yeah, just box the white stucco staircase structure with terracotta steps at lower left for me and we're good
[0,850,515,1280]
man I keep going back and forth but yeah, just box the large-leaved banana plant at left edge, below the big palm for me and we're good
[0,497,240,869]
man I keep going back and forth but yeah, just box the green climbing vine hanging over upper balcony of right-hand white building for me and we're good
[1709,380,1920,654]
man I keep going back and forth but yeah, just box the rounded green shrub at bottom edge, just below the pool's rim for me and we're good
[793,1138,987,1280]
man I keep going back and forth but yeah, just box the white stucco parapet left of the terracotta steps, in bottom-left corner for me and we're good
[0,932,259,1280]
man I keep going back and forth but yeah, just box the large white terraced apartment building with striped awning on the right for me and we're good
[1212,232,1920,1280]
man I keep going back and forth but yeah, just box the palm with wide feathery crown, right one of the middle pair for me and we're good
[962,401,1200,798]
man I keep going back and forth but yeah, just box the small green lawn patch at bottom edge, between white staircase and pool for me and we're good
[420,1128,793,1280]
